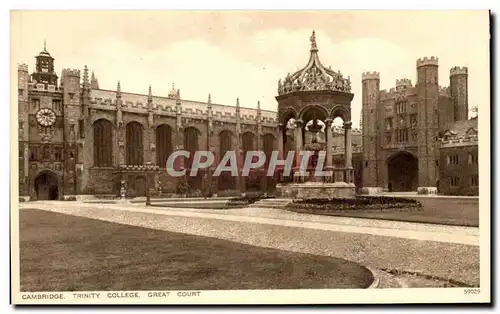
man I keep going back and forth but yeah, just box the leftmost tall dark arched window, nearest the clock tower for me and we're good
[92,119,113,167]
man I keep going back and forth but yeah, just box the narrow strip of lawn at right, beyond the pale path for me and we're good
[288,197,479,227]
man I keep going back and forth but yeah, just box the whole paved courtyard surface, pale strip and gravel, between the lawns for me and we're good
[20,201,479,287]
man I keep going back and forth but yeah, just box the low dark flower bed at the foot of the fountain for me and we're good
[287,196,422,212]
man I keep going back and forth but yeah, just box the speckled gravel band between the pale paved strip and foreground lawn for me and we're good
[22,203,479,286]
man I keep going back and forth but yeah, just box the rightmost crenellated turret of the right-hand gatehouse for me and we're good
[450,67,469,121]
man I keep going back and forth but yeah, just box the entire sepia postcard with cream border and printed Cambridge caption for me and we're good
[10,10,491,305]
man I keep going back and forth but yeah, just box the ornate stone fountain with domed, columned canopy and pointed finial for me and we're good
[276,31,356,199]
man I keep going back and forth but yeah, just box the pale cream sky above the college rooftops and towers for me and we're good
[11,11,490,127]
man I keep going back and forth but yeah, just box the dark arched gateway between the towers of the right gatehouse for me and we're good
[387,152,418,192]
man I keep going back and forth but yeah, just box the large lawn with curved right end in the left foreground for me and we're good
[19,209,373,291]
